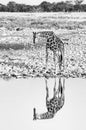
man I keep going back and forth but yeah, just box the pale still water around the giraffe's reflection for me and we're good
[0,78,86,130]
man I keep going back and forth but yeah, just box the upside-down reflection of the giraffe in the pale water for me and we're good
[33,77,65,120]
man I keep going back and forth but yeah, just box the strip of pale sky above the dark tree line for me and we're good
[0,0,86,5]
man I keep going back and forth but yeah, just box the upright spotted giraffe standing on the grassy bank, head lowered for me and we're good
[33,31,64,72]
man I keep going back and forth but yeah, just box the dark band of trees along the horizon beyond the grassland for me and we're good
[0,0,86,12]
